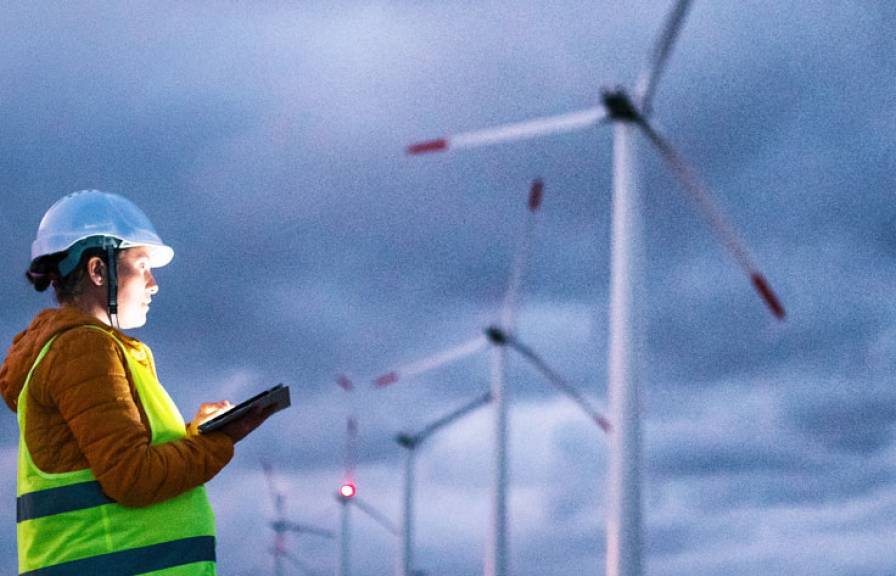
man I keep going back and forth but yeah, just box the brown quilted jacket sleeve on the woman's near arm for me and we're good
[47,329,233,507]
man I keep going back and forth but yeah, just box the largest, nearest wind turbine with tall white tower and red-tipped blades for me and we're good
[407,0,785,576]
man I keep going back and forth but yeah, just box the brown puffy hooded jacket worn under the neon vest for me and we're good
[0,306,233,506]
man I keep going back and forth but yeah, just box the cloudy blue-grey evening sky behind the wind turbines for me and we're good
[0,0,896,576]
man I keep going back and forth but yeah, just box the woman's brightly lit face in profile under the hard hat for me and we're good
[118,246,159,329]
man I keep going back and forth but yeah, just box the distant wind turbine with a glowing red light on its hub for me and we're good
[336,375,399,576]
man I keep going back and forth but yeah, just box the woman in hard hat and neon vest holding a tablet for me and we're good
[0,190,269,576]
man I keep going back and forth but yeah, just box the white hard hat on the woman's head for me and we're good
[31,190,174,276]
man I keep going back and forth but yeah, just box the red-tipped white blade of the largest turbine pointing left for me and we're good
[407,107,605,155]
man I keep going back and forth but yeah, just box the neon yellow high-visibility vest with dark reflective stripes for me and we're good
[16,326,215,576]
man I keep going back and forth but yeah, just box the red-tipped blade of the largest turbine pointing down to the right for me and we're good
[638,119,785,320]
